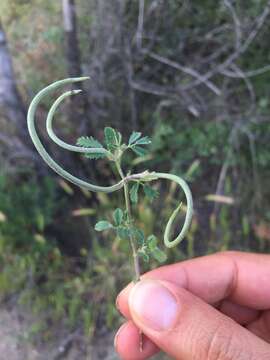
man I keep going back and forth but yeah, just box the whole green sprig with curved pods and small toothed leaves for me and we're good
[27,78,193,281]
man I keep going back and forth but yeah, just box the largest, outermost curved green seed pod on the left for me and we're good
[27,77,124,193]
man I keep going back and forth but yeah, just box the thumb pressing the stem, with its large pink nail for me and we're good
[129,280,270,360]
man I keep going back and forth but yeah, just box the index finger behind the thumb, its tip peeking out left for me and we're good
[117,252,270,317]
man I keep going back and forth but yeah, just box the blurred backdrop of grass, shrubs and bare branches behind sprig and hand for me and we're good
[0,0,270,360]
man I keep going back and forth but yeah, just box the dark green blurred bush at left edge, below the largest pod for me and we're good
[0,175,58,251]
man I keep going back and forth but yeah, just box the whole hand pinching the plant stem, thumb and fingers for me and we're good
[115,252,270,360]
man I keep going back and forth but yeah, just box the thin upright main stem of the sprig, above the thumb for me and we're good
[116,160,141,282]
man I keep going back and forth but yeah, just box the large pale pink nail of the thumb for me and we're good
[129,280,180,331]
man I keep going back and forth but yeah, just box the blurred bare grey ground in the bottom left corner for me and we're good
[0,305,168,360]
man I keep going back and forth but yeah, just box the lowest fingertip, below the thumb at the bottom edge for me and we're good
[114,321,160,360]
